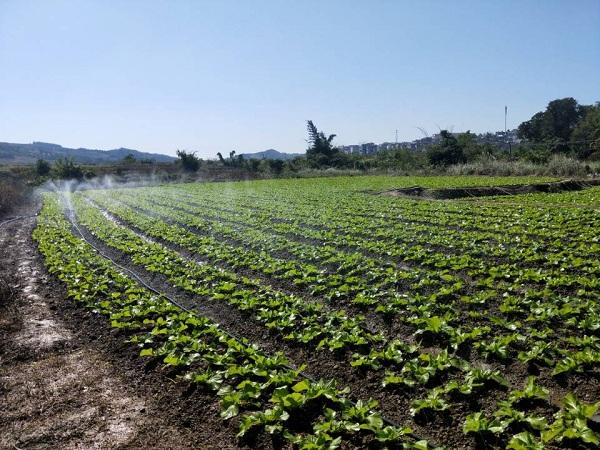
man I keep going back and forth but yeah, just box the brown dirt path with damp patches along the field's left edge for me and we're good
[0,201,252,450]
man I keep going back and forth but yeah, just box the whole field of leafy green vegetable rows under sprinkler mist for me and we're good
[34,177,600,450]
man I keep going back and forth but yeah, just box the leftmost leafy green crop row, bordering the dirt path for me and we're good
[33,195,436,449]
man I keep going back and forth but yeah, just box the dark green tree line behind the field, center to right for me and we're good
[178,97,600,174]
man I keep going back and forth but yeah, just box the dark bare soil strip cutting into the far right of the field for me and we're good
[376,179,600,200]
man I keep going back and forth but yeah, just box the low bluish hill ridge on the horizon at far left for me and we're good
[0,142,176,164]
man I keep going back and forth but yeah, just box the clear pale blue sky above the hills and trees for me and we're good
[0,0,600,157]
